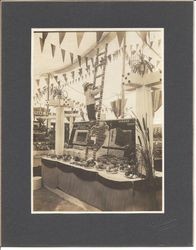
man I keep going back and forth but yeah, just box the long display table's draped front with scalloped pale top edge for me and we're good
[42,157,161,211]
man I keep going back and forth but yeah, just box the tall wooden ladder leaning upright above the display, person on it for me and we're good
[85,43,108,160]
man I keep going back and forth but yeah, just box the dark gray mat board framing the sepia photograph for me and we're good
[2,2,193,247]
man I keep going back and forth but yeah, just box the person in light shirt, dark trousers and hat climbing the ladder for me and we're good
[83,82,101,121]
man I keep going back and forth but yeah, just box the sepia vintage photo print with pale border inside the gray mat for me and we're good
[31,28,164,213]
